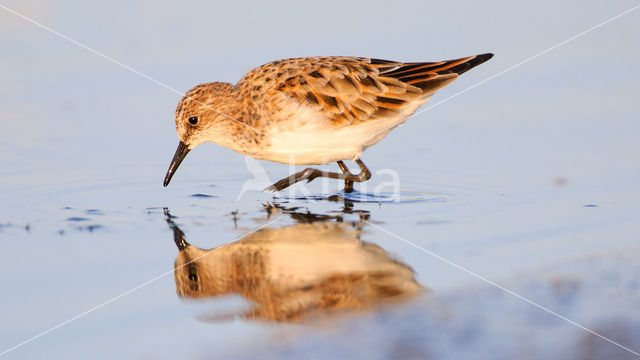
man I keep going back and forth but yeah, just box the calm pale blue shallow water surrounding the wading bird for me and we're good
[0,1,640,359]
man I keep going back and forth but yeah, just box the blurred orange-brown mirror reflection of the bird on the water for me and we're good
[165,206,423,323]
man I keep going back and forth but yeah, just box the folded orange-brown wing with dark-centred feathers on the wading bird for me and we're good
[243,54,491,126]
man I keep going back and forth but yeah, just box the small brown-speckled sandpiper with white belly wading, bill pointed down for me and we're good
[163,53,493,192]
